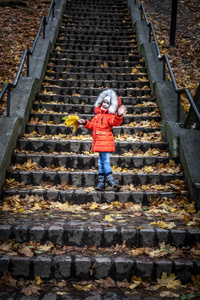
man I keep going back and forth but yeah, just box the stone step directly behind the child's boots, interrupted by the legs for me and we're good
[7,168,183,187]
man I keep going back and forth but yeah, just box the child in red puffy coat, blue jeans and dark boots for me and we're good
[77,89,127,191]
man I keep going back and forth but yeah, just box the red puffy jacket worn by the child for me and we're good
[84,98,123,152]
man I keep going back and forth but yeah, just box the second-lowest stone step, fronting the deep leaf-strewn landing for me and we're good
[0,217,200,247]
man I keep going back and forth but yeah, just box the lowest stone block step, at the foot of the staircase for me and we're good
[0,253,200,283]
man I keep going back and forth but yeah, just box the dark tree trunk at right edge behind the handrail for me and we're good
[184,84,200,129]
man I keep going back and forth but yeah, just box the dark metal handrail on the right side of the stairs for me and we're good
[135,0,200,123]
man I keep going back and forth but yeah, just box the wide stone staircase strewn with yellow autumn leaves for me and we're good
[0,0,200,299]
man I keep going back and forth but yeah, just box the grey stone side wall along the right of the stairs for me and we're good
[127,0,200,210]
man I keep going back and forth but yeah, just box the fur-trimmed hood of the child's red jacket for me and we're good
[94,89,121,114]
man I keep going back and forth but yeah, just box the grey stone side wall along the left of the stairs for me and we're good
[0,0,66,195]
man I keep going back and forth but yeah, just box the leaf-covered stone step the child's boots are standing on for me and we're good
[2,188,187,206]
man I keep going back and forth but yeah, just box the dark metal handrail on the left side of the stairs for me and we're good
[0,0,58,117]
